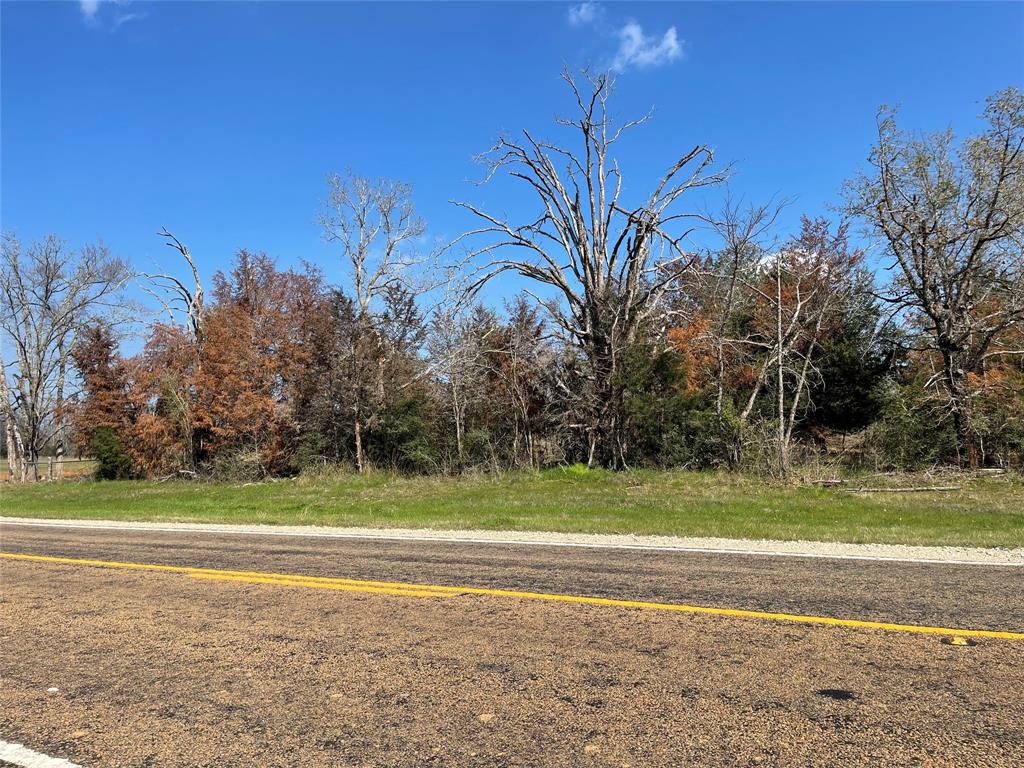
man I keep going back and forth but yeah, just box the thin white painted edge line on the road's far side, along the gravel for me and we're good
[0,517,1024,568]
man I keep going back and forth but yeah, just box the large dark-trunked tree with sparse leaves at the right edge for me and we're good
[847,88,1024,467]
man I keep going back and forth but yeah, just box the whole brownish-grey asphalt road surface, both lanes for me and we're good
[0,525,1024,766]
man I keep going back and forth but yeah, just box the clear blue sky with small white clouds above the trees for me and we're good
[0,0,1024,309]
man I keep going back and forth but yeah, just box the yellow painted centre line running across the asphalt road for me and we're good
[0,552,1024,640]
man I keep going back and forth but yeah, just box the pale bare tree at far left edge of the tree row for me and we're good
[0,234,131,480]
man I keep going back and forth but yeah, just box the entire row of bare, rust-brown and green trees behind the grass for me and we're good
[0,74,1024,480]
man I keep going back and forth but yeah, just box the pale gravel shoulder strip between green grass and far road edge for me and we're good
[0,516,1024,566]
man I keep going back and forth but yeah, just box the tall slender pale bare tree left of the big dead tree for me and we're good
[321,173,433,472]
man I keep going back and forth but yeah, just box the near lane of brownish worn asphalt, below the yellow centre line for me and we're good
[0,561,1024,766]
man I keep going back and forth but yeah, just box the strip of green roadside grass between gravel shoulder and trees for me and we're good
[0,468,1024,547]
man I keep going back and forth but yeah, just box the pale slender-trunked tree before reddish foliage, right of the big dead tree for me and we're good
[694,208,870,477]
